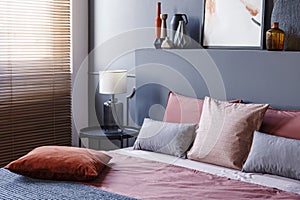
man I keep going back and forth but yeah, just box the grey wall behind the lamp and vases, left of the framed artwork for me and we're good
[88,0,202,126]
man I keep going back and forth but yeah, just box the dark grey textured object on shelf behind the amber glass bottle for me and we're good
[271,0,300,51]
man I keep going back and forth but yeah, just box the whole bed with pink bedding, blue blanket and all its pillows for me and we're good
[0,92,300,199]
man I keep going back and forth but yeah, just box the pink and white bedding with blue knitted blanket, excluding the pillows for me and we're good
[0,145,300,200]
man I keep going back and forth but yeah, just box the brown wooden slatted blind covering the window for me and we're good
[0,0,71,167]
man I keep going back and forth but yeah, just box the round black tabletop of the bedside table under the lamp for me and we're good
[79,126,139,139]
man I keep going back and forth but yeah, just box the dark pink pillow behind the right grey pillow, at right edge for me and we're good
[260,108,300,140]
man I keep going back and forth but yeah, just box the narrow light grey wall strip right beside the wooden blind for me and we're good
[72,0,88,146]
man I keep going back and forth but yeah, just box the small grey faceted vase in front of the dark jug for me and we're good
[174,21,191,48]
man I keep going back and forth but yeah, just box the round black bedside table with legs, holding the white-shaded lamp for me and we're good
[79,126,139,148]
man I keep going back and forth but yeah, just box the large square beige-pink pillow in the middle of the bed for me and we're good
[188,97,269,169]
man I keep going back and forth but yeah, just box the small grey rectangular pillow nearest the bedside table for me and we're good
[133,118,197,158]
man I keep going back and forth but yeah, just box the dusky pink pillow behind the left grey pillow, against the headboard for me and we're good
[163,92,241,123]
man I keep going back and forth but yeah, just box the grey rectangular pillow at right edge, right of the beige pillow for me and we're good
[243,131,300,180]
